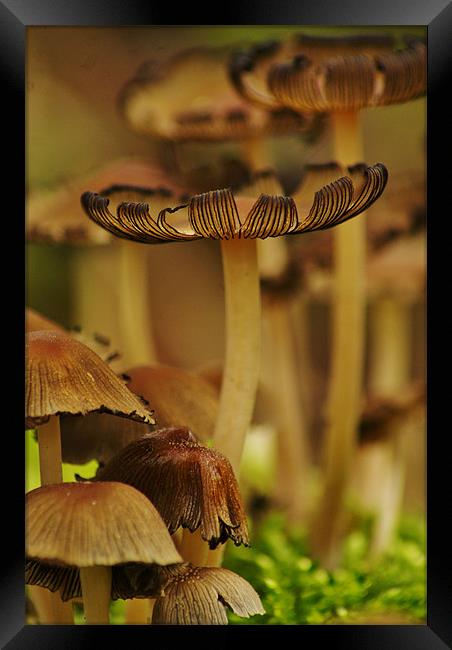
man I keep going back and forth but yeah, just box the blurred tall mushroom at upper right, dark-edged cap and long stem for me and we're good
[231,35,426,564]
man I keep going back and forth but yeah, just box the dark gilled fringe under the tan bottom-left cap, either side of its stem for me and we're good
[25,558,168,601]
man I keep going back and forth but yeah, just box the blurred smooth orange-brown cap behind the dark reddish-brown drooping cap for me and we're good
[125,364,219,440]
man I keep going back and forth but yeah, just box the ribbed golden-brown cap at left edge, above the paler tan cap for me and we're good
[25,330,154,428]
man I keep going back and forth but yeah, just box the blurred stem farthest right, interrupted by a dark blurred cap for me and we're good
[369,297,411,555]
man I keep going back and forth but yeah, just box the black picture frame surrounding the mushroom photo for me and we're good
[5,0,452,650]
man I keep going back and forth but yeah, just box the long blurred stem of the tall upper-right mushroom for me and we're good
[311,112,366,566]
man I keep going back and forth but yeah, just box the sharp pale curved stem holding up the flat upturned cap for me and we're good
[213,239,261,476]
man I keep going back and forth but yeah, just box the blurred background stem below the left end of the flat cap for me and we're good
[118,240,157,366]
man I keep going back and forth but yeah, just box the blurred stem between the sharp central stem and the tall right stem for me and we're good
[266,301,310,522]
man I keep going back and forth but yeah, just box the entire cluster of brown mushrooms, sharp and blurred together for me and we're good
[25,34,426,625]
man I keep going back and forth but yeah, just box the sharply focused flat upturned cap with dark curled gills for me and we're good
[81,163,388,244]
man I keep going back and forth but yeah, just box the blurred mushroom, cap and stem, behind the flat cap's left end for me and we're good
[26,158,189,365]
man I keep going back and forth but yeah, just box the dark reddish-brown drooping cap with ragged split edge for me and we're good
[96,427,248,548]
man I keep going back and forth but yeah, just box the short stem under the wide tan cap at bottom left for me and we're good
[80,566,111,625]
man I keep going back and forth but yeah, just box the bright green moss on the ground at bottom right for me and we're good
[224,514,426,625]
